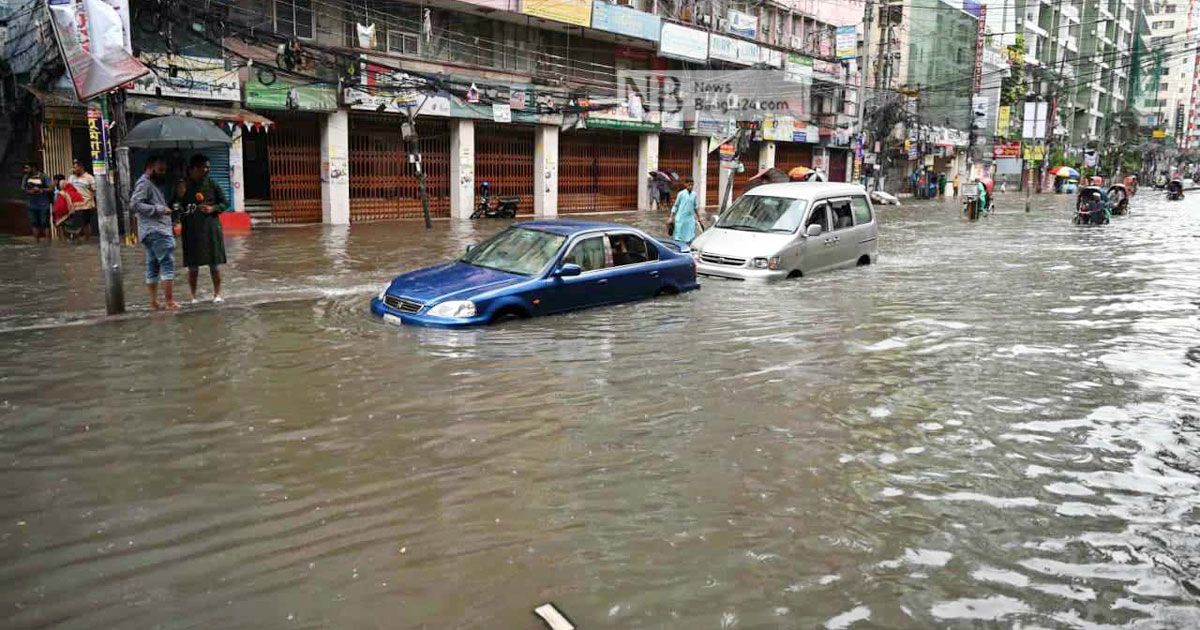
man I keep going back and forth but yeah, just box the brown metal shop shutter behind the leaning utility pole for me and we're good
[349,114,450,222]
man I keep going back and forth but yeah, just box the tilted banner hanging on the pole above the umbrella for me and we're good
[46,0,150,101]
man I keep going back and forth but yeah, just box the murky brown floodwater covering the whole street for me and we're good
[0,192,1200,629]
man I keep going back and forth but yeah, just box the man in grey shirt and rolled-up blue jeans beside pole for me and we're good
[130,157,179,311]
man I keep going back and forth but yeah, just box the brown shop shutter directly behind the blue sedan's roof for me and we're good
[558,131,648,214]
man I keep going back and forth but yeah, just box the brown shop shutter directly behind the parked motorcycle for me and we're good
[472,122,534,215]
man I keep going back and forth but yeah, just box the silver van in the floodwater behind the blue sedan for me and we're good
[691,182,880,280]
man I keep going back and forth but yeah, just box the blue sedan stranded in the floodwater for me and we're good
[371,220,700,326]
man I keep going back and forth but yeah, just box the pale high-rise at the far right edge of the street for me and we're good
[1142,0,1200,148]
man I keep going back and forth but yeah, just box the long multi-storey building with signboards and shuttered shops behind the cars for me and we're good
[0,0,862,228]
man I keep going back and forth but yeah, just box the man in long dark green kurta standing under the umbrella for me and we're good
[175,154,228,304]
